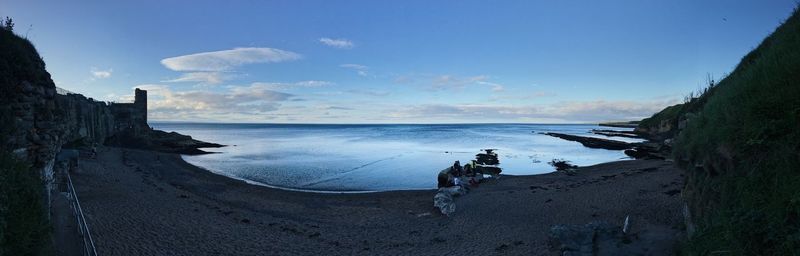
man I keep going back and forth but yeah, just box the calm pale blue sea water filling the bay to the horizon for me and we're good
[152,123,639,191]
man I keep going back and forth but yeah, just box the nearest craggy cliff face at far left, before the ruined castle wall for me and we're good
[0,27,65,184]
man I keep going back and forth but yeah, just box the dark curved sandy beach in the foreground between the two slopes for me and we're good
[73,147,684,255]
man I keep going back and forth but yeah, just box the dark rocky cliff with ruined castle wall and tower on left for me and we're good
[0,29,222,202]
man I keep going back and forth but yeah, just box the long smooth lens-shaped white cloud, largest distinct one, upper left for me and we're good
[161,47,302,72]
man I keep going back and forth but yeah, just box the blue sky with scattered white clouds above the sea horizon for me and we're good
[0,0,796,123]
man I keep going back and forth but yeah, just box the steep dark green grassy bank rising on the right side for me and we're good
[638,7,800,255]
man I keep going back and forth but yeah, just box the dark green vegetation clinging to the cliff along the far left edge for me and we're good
[0,18,52,255]
